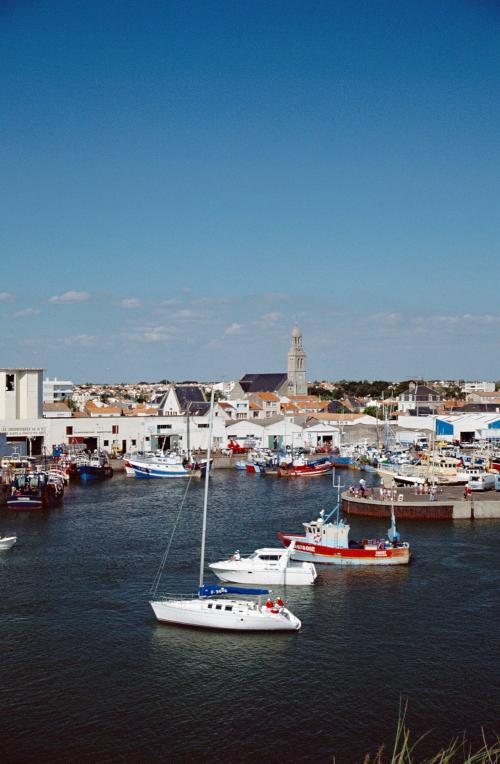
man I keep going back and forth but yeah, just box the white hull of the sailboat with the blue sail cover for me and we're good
[150,598,301,631]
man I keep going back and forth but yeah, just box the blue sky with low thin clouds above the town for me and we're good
[0,0,500,381]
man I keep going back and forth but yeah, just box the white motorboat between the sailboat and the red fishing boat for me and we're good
[208,542,318,586]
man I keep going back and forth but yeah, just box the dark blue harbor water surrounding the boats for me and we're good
[0,470,500,764]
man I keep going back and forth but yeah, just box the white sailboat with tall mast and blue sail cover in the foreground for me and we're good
[150,388,301,632]
